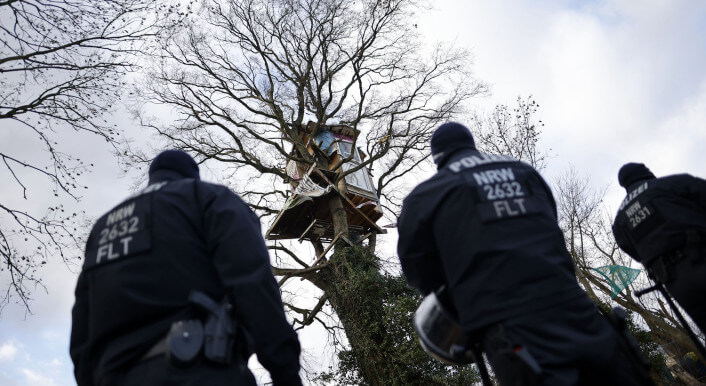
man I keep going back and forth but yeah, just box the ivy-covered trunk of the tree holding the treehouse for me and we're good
[316,246,451,386]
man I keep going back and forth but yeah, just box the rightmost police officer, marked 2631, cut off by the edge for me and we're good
[613,163,706,332]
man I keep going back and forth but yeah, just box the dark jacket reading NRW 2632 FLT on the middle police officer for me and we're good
[398,149,585,332]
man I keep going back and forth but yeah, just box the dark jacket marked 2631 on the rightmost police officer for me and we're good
[613,174,706,265]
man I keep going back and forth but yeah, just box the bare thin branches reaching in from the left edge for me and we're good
[0,0,188,311]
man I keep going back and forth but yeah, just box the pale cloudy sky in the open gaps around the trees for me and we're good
[0,0,706,386]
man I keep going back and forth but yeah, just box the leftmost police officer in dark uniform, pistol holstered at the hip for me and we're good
[70,150,301,386]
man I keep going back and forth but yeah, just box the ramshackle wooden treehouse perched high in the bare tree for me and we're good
[265,122,386,242]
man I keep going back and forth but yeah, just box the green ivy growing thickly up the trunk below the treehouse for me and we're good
[317,247,479,385]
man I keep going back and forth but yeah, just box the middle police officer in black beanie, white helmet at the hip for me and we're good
[398,122,650,385]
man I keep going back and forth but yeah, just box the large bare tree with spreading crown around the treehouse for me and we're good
[122,0,485,377]
